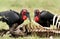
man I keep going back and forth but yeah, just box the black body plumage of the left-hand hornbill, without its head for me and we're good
[0,10,24,27]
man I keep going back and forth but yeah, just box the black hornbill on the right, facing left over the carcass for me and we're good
[34,9,59,27]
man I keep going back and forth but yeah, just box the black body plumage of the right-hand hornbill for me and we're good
[35,11,54,27]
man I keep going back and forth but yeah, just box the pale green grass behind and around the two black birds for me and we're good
[0,0,60,39]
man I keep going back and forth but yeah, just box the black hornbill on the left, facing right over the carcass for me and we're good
[0,9,30,36]
